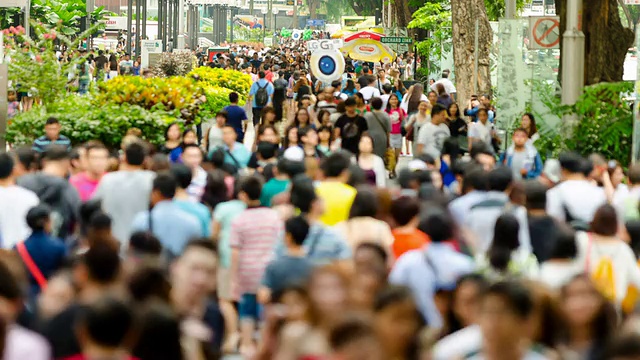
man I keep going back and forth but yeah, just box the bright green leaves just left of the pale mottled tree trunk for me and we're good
[409,2,452,74]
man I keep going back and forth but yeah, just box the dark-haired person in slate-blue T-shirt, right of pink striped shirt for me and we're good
[258,216,313,304]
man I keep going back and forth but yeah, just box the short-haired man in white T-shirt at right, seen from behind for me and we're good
[547,152,607,227]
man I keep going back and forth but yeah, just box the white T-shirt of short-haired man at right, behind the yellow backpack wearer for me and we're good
[547,180,607,223]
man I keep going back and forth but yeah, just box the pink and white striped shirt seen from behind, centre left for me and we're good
[229,207,284,295]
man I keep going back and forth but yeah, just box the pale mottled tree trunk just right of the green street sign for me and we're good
[451,0,493,106]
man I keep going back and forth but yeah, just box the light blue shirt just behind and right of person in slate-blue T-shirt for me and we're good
[275,223,352,265]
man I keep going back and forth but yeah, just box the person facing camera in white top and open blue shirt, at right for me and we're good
[500,128,542,179]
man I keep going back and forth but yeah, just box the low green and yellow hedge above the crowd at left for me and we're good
[6,95,179,149]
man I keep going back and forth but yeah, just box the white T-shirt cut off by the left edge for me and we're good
[0,185,40,249]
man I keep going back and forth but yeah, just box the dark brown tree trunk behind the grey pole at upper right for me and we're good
[556,0,634,85]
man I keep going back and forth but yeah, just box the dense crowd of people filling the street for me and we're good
[0,38,640,360]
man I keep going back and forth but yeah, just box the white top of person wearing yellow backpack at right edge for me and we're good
[576,231,640,303]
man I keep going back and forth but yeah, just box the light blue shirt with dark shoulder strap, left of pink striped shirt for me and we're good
[131,200,202,256]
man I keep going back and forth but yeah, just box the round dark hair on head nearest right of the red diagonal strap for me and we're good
[81,242,120,284]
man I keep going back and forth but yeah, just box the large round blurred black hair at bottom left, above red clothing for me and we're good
[79,297,134,348]
